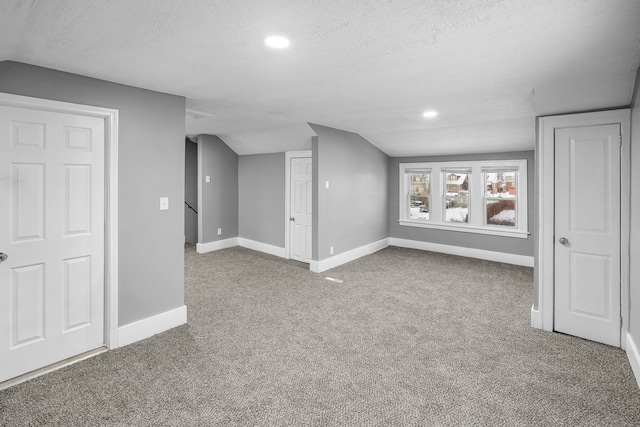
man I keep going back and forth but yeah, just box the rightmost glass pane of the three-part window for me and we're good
[484,171,518,227]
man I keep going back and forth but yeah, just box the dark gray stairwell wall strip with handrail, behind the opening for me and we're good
[183,139,198,245]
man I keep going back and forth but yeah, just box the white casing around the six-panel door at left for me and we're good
[0,92,118,349]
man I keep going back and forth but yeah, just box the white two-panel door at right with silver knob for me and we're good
[554,124,620,347]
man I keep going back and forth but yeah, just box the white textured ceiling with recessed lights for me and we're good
[0,0,640,156]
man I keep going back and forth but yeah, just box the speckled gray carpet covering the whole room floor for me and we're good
[0,247,640,426]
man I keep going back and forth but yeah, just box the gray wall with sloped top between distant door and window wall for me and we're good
[311,124,389,261]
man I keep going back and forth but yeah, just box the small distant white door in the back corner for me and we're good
[289,157,313,262]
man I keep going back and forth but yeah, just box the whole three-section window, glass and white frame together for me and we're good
[398,160,529,238]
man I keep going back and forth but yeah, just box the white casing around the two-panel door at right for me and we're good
[531,109,631,349]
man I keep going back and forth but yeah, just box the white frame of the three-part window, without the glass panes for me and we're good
[398,159,529,239]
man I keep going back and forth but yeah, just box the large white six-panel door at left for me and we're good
[0,106,105,382]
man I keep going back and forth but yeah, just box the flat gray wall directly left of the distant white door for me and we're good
[238,153,285,248]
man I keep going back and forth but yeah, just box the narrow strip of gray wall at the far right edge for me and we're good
[629,70,640,346]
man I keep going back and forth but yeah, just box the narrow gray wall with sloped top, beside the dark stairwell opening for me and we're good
[198,135,238,243]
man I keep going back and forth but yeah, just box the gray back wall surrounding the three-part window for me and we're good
[389,151,535,256]
